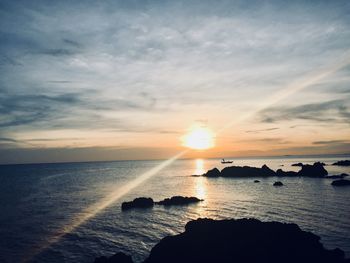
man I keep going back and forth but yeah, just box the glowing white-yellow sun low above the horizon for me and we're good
[182,127,215,150]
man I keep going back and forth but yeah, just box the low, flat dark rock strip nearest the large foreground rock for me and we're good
[122,196,204,211]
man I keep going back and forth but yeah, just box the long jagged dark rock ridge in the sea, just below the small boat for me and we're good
[203,162,328,178]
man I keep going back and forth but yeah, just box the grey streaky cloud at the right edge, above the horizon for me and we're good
[260,100,350,123]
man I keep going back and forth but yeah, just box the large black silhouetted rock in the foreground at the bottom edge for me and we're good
[144,219,346,263]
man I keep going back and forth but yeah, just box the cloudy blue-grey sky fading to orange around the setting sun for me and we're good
[0,0,350,163]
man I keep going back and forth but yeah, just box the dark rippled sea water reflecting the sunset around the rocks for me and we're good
[0,157,350,263]
